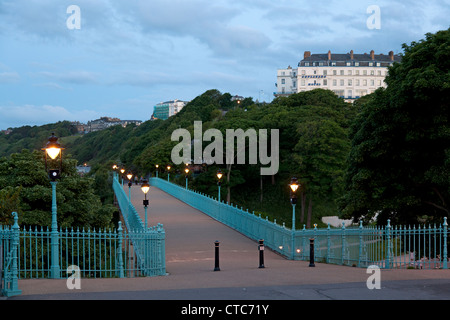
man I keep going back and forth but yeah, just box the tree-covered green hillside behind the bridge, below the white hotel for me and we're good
[0,89,356,227]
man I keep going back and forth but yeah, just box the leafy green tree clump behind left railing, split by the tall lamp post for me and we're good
[0,149,116,228]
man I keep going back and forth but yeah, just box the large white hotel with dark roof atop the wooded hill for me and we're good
[274,50,401,101]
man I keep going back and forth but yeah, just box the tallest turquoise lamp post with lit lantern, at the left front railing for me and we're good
[43,133,63,279]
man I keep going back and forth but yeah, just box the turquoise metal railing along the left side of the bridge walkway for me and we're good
[113,175,166,276]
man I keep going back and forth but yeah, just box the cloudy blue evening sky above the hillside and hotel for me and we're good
[0,0,450,130]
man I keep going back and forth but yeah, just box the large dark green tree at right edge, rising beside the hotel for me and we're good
[340,29,450,223]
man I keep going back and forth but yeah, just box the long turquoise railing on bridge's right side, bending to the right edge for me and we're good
[150,178,448,269]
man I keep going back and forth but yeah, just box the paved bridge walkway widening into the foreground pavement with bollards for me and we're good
[8,186,450,300]
